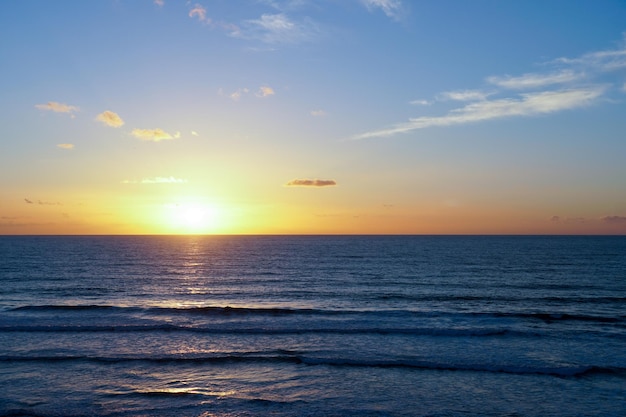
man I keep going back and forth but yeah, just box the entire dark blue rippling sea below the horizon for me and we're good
[0,236,626,417]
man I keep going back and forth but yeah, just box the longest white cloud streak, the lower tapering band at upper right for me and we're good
[353,86,605,139]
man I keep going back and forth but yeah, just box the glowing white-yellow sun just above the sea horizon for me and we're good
[166,202,219,234]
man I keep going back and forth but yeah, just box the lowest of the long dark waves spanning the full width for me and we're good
[0,352,626,378]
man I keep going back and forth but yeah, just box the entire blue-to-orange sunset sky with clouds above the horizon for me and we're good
[0,0,626,235]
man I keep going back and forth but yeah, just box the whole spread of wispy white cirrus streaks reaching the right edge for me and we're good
[352,36,626,140]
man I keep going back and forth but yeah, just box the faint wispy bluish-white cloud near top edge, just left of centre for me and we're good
[231,13,319,44]
